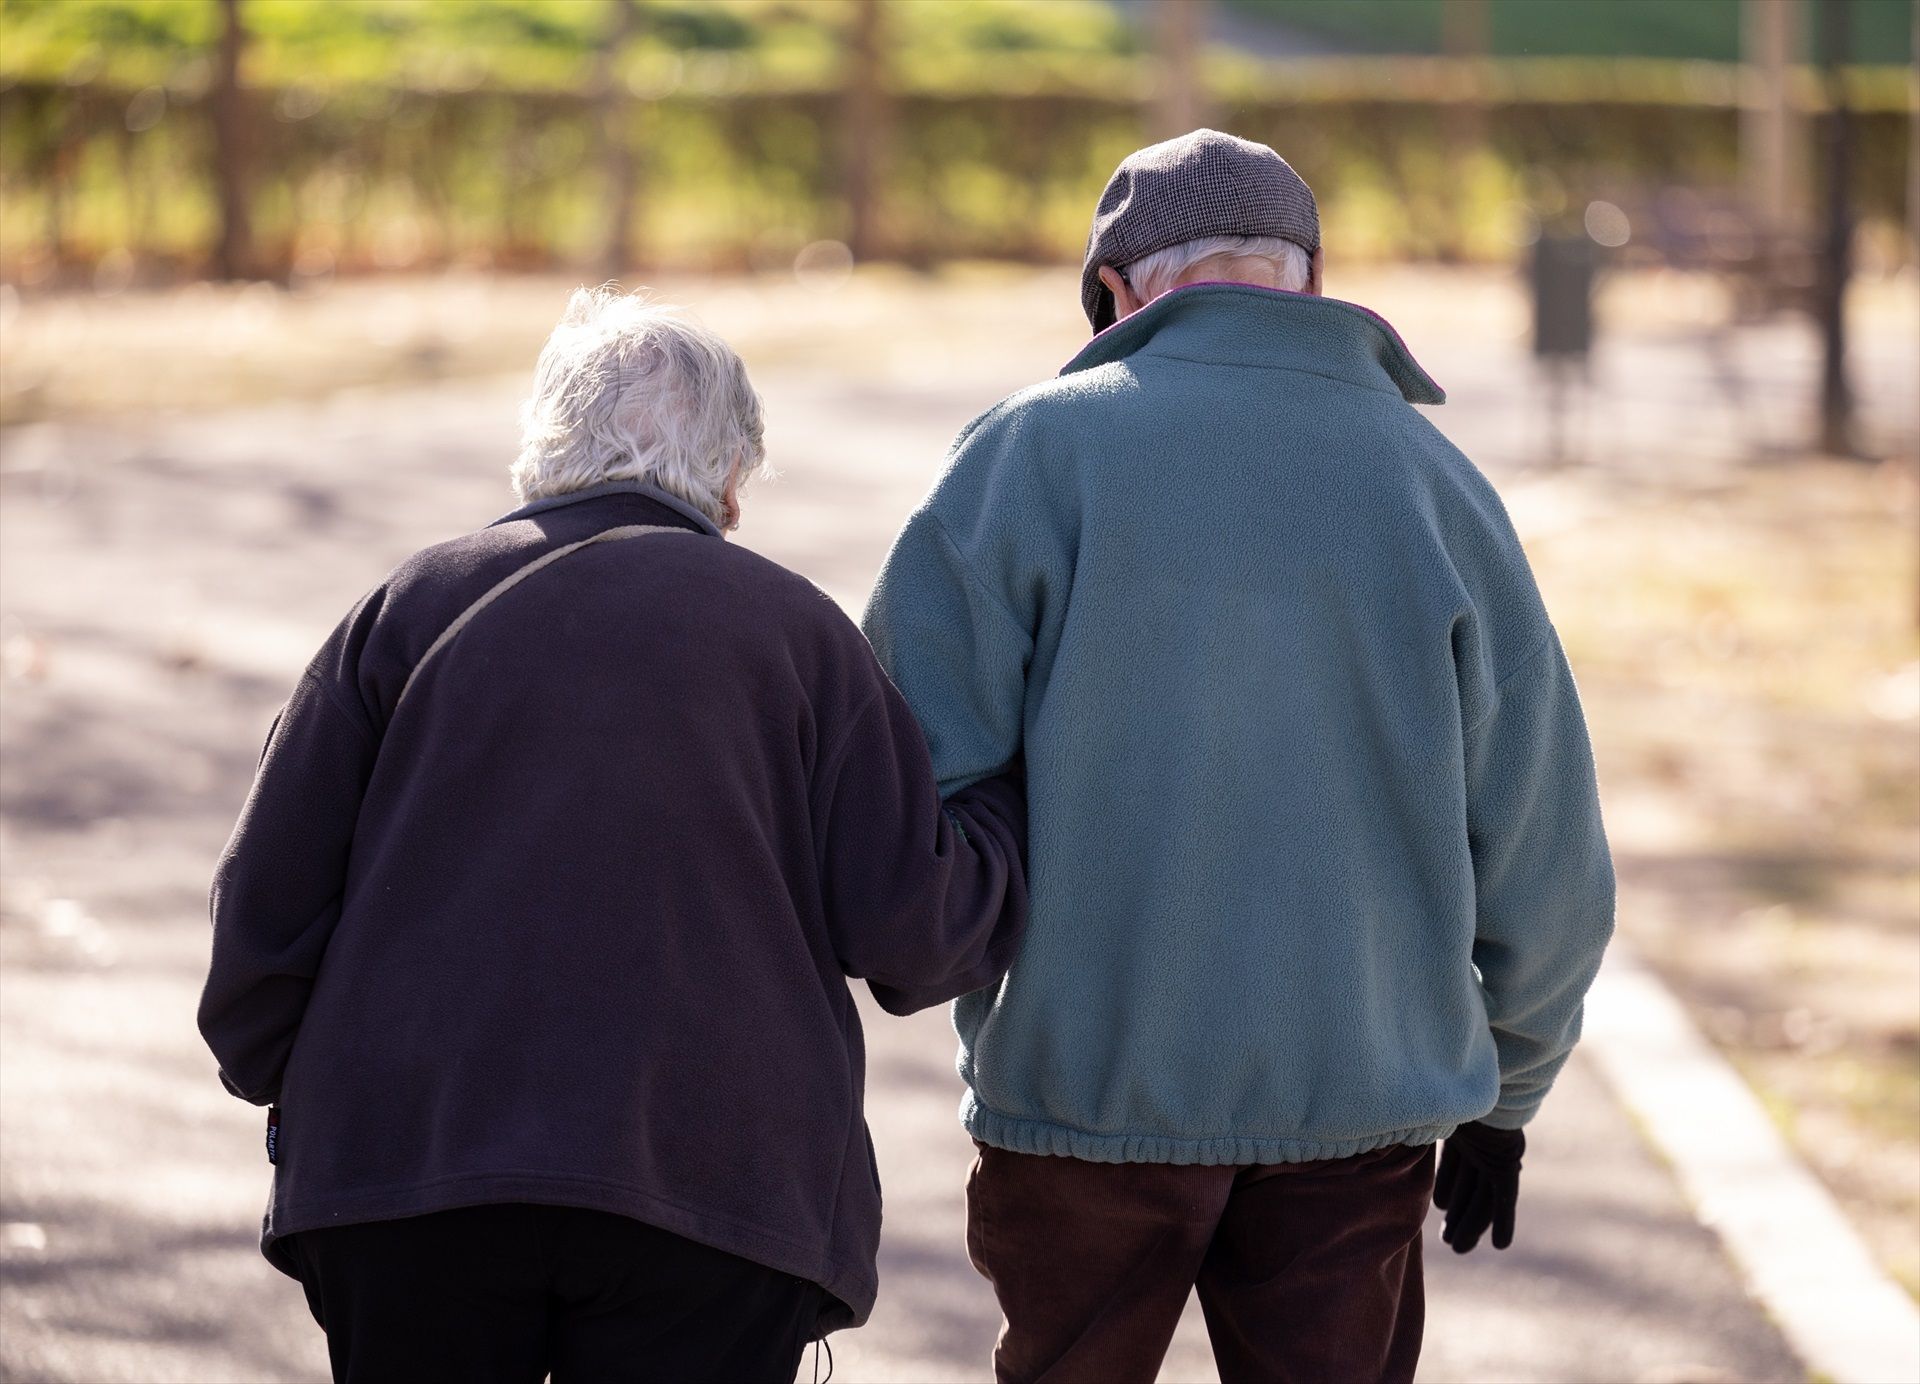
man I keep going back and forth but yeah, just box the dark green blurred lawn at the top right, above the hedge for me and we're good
[1223,0,1912,63]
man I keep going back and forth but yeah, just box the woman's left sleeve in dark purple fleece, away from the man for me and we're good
[200,672,376,1106]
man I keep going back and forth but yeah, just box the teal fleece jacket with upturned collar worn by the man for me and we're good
[864,284,1613,1163]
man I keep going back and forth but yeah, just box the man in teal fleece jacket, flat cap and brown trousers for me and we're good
[866,131,1613,1384]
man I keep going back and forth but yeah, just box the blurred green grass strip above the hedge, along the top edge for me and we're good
[0,0,1910,96]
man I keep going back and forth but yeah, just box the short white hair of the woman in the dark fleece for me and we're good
[511,288,766,526]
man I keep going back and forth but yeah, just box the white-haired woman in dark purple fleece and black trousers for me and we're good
[200,290,1025,1384]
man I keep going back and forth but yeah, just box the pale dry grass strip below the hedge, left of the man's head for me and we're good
[0,265,1085,426]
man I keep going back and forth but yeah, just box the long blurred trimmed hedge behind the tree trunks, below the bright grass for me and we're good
[0,81,1908,278]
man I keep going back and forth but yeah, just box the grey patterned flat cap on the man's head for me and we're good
[1081,131,1319,332]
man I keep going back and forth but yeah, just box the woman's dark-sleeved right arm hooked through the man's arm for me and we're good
[814,674,1027,1014]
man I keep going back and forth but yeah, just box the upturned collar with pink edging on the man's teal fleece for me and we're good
[1060,284,1446,403]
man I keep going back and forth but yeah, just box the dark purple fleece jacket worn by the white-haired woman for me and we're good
[200,484,1025,1332]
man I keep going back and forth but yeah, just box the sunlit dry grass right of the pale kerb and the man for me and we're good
[1517,461,1920,1294]
